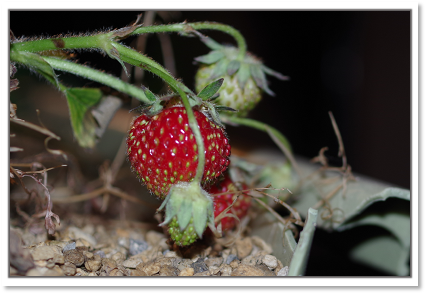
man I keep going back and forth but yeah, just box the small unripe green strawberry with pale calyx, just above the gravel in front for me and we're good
[158,181,214,245]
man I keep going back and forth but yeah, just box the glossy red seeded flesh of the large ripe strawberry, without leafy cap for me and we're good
[127,106,231,199]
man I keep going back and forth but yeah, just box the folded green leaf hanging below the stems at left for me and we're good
[65,88,102,148]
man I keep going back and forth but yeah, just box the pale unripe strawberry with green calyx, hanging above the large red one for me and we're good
[195,38,288,117]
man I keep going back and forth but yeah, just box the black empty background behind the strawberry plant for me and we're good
[10,9,411,275]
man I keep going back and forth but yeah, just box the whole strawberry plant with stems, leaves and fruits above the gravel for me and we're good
[9,10,410,275]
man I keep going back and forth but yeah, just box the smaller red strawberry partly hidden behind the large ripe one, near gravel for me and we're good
[209,173,251,231]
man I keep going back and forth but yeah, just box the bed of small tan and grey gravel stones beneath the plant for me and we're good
[9,215,288,277]
